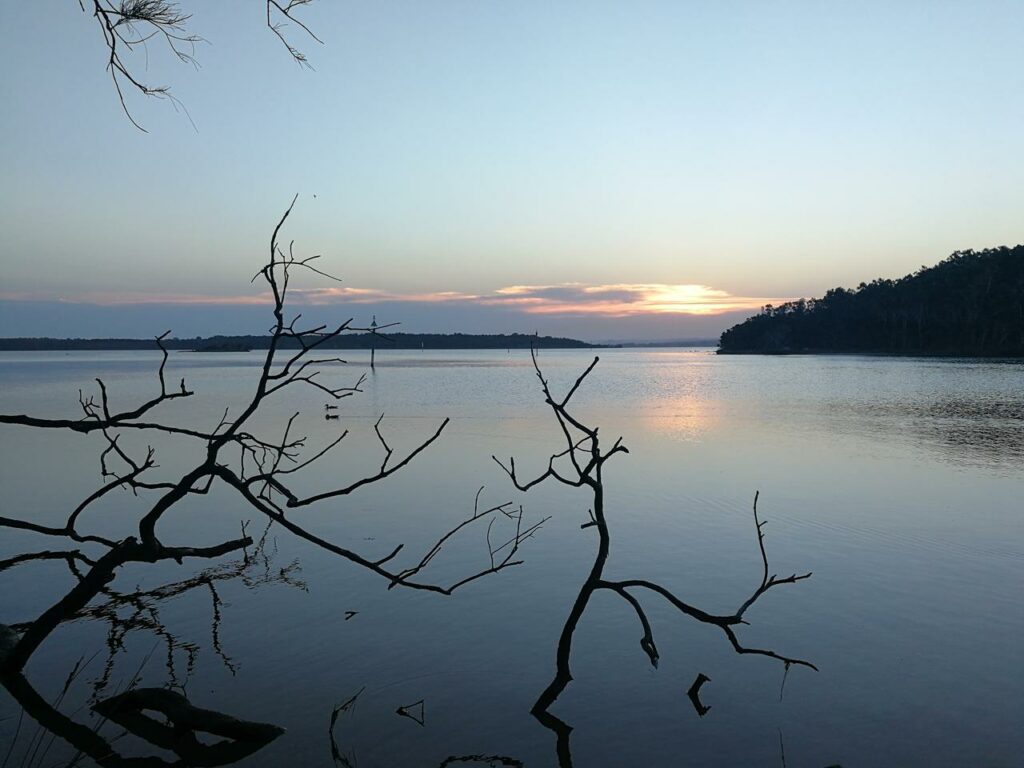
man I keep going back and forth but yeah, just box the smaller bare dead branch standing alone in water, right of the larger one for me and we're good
[495,350,817,767]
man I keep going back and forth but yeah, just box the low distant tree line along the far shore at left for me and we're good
[0,333,594,352]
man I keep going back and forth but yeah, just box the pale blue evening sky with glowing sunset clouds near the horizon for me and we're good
[0,0,1024,340]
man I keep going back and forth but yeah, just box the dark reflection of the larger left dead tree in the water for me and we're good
[0,530,305,767]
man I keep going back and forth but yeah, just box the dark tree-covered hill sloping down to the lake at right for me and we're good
[719,245,1024,356]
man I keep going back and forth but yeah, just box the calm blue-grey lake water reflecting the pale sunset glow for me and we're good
[0,349,1024,768]
